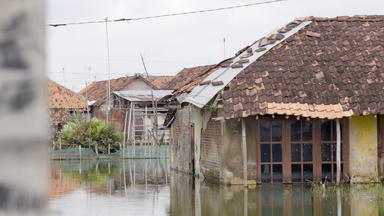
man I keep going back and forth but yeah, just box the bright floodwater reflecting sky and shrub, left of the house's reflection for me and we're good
[48,160,170,216]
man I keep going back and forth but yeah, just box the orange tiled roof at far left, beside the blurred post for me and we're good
[48,79,86,109]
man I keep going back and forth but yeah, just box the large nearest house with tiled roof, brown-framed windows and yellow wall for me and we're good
[166,16,384,184]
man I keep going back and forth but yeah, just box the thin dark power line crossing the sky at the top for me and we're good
[48,0,286,27]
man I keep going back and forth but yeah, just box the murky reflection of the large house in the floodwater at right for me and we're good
[170,173,384,216]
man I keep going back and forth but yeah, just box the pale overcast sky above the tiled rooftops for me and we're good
[46,0,384,91]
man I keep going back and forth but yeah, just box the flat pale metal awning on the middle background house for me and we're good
[113,90,173,102]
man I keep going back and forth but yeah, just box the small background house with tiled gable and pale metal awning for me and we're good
[80,74,172,142]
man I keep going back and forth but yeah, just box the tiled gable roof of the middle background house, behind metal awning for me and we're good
[79,74,168,106]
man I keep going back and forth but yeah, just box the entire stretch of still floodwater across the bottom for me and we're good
[48,160,384,216]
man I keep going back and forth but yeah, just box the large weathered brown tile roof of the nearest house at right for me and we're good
[219,16,384,118]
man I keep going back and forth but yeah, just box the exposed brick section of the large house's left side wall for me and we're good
[200,110,222,180]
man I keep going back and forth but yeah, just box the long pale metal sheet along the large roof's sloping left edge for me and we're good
[183,21,311,108]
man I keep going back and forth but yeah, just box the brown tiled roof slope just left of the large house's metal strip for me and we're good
[169,65,216,96]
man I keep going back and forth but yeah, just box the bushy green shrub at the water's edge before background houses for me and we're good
[60,113,123,154]
